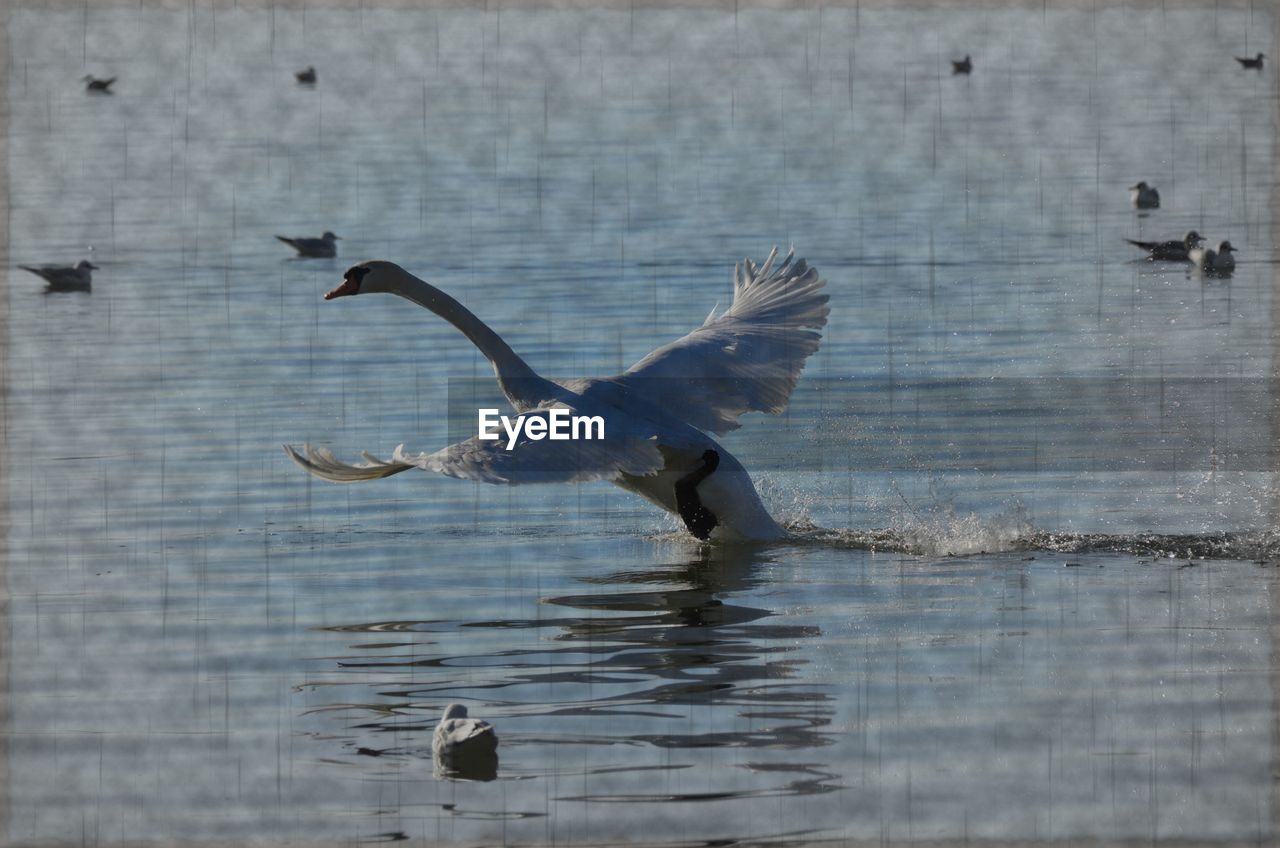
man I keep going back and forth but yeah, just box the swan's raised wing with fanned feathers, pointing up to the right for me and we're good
[593,247,829,433]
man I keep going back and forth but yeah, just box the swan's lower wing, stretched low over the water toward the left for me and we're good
[284,409,663,484]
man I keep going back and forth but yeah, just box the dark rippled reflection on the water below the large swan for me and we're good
[317,546,840,801]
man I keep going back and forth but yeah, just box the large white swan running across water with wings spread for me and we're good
[284,247,829,541]
